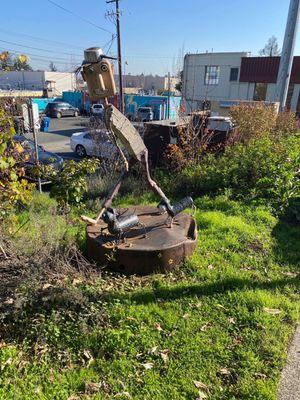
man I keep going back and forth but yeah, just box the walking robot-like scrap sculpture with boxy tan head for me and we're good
[81,47,193,235]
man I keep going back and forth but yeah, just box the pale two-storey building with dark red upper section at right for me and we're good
[183,52,300,115]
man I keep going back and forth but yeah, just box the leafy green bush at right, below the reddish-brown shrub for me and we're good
[171,134,300,208]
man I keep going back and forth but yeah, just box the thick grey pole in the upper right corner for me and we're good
[276,0,300,111]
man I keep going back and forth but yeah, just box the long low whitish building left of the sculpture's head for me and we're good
[0,71,76,96]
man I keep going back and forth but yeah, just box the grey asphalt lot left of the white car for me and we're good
[27,117,88,159]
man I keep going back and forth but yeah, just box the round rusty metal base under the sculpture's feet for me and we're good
[86,206,197,275]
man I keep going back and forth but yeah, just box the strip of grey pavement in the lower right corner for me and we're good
[278,325,300,400]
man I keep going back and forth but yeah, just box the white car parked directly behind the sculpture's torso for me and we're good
[70,130,117,159]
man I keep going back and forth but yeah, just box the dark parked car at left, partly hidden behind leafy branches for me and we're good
[13,135,64,180]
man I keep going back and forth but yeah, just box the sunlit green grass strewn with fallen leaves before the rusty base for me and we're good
[0,196,300,400]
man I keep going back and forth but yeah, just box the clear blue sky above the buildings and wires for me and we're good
[0,0,300,74]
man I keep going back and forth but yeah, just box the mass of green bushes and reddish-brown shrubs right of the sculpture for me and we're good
[163,104,300,211]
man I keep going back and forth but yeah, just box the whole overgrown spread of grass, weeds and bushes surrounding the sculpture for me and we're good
[0,104,300,400]
